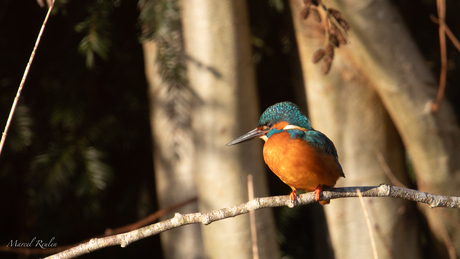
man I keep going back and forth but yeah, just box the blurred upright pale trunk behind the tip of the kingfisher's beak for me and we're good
[181,0,279,258]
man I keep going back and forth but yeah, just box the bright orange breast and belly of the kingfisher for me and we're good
[263,132,341,192]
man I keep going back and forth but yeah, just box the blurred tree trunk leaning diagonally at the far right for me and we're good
[330,0,460,258]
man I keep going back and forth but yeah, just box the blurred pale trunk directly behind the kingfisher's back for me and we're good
[290,0,421,258]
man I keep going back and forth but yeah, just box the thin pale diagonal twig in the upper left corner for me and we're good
[0,0,54,155]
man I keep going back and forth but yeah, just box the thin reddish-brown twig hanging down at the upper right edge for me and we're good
[431,0,447,112]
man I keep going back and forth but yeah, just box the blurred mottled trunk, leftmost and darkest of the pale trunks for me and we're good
[142,30,205,259]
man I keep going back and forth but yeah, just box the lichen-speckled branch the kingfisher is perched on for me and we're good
[42,184,460,259]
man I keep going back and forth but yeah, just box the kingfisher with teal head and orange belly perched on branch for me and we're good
[227,102,345,205]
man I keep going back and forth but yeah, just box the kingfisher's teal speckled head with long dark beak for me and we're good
[227,102,313,146]
